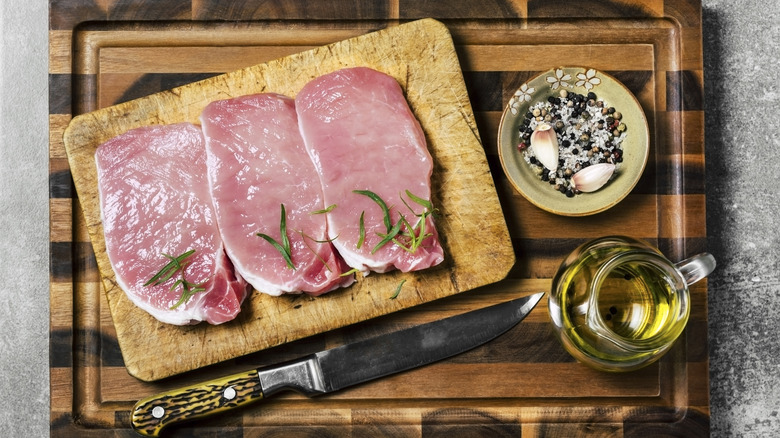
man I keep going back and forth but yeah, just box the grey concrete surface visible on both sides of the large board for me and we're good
[0,0,780,437]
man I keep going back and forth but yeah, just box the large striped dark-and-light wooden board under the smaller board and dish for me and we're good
[49,0,709,437]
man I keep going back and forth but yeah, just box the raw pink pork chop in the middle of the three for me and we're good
[201,94,354,295]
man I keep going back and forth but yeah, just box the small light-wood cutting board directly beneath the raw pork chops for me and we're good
[63,19,515,381]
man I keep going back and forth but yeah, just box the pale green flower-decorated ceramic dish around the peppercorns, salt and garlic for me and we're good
[498,67,649,216]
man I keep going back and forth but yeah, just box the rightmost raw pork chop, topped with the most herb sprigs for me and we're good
[296,67,444,273]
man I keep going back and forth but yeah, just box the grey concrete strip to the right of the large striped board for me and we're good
[704,0,780,437]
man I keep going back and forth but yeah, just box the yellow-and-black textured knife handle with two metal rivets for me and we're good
[131,370,264,437]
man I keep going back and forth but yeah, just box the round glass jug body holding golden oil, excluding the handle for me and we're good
[548,237,689,371]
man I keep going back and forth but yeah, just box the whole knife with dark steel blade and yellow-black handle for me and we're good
[131,292,544,437]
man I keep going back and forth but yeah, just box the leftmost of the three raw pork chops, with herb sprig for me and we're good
[95,123,247,325]
